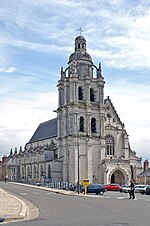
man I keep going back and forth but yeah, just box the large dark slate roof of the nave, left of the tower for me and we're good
[28,118,57,143]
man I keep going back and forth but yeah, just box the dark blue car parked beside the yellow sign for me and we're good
[81,184,105,195]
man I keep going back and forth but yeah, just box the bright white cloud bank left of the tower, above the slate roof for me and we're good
[0,92,57,153]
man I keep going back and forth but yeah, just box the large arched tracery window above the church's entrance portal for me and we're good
[105,134,115,155]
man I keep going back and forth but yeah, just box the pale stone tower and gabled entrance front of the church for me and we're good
[57,36,141,183]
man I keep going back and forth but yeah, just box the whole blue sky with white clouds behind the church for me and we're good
[0,0,150,160]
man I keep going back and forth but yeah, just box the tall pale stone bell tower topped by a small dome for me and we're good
[57,35,105,183]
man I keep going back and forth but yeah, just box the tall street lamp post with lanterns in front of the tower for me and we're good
[68,122,89,194]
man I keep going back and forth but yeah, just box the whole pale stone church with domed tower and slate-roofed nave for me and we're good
[5,35,142,184]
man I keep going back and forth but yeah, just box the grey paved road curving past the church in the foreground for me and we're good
[0,183,150,226]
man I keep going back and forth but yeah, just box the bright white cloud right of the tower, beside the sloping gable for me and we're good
[105,80,150,157]
